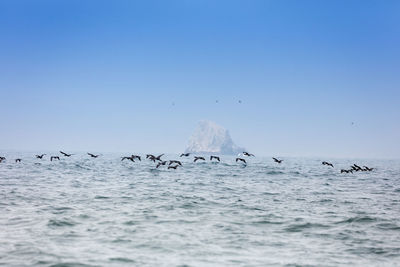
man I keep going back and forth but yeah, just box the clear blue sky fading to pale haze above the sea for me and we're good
[0,0,400,158]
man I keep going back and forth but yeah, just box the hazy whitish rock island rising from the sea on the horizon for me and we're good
[185,120,245,155]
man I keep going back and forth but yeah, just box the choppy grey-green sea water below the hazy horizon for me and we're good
[0,151,400,266]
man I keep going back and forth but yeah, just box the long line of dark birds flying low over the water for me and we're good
[0,151,374,173]
